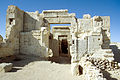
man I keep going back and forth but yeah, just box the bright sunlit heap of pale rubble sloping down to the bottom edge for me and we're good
[79,56,106,80]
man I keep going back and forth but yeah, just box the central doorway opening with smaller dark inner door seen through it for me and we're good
[49,26,71,64]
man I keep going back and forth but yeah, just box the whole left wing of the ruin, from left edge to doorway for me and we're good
[0,5,49,57]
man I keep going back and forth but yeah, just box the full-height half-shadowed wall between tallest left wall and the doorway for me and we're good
[20,11,49,57]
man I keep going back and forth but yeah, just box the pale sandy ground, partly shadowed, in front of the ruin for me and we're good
[0,55,120,80]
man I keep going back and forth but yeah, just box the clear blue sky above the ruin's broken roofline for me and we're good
[0,0,120,42]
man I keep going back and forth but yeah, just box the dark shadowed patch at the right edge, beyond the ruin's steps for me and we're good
[110,45,120,63]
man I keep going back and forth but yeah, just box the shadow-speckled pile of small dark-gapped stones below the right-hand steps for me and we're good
[86,57,120,71]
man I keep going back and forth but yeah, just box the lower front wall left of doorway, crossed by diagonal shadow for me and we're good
[20,27,49,57]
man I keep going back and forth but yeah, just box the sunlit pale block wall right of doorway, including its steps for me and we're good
[71,14,114,73]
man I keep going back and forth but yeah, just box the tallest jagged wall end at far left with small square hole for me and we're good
[6,6,24,54]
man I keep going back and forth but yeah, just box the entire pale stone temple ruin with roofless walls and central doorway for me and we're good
[0,5,118,80]
